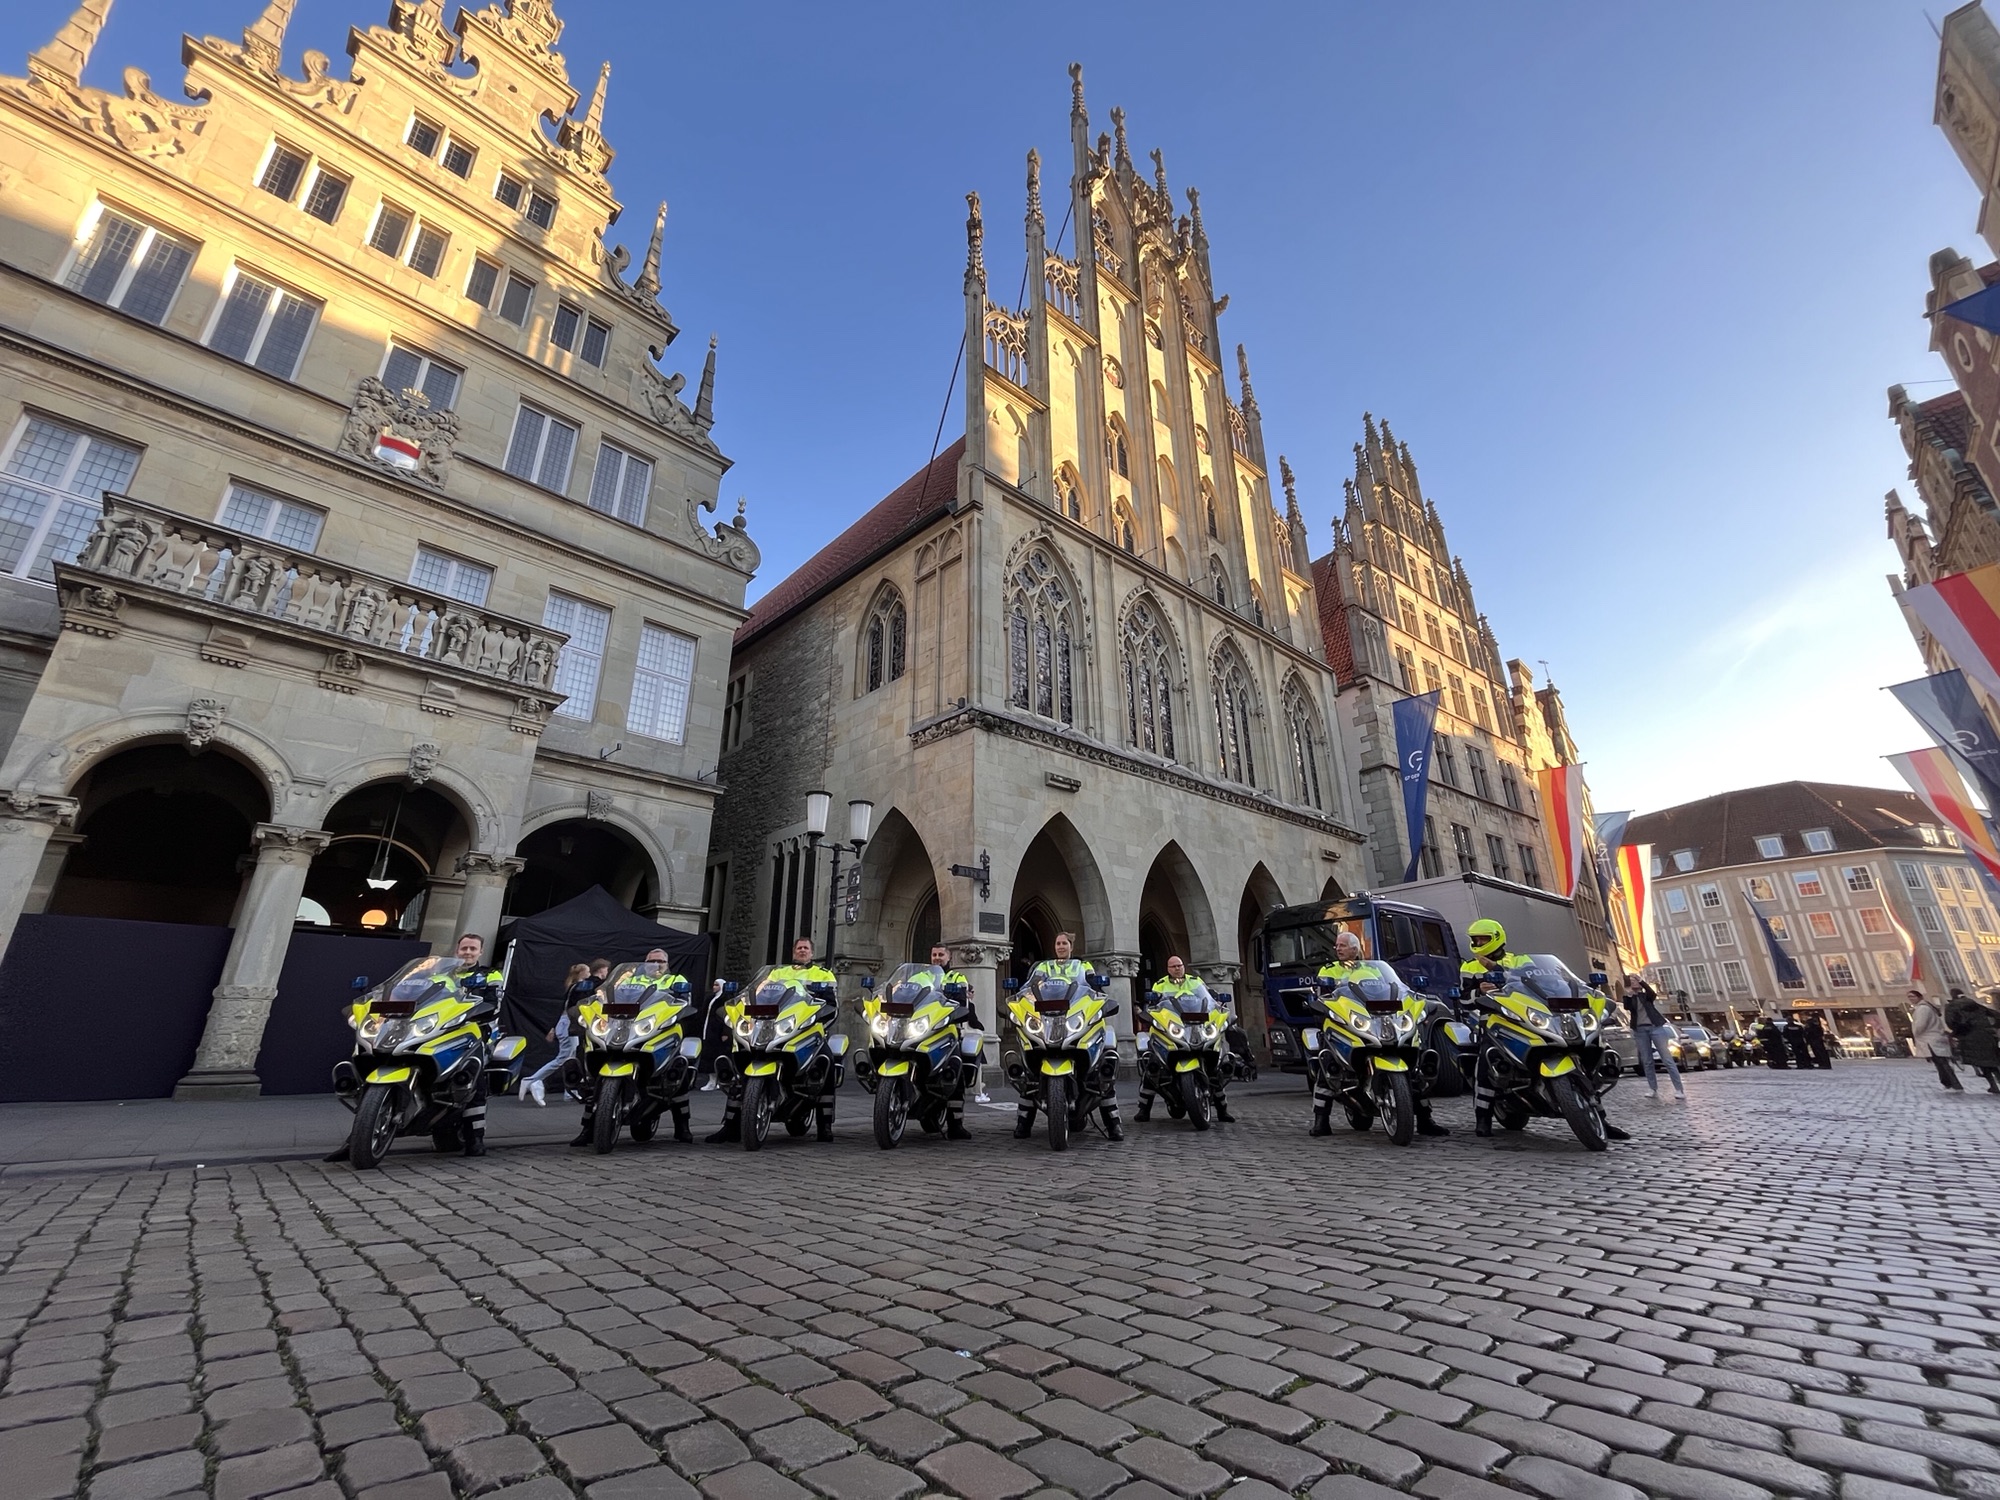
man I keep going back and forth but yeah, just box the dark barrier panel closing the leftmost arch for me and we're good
[0,916,230,1104]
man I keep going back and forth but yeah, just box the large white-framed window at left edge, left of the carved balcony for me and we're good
[0,412,140,584]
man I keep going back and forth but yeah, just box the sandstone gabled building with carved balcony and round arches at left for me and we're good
[0,0,758,1092]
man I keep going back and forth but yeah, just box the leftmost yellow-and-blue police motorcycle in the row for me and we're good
[334,954,528,1170]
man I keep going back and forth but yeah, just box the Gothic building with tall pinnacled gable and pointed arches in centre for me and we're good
[712,68,1366,1056]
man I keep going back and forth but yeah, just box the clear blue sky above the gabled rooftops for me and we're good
[0,0,1986,824]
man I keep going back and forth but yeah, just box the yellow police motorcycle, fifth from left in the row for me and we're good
[1006,972,1118,1152]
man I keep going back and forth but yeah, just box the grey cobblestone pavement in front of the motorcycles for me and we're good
[0,1062,2000,1500]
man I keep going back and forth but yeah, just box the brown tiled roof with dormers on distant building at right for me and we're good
[1624,782,1956,880]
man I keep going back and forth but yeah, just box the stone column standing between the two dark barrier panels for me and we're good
[174,822,334,1098]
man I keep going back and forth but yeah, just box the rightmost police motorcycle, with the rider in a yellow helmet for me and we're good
[1474,954,1618,1152]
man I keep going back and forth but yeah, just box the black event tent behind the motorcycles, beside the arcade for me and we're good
[498,886,710,1064]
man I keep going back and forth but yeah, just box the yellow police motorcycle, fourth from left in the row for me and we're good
[854,964,984,1150]
